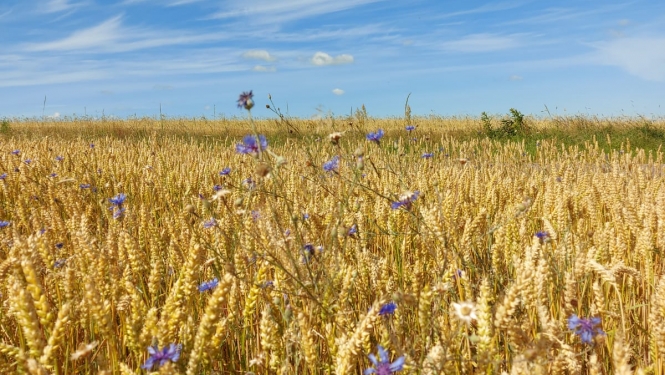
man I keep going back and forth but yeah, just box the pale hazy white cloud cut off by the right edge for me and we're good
[594,36,665,81]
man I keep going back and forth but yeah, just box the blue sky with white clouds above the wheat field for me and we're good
[0,0,665,118]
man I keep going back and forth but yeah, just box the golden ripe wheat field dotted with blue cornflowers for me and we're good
[0,116,665,375]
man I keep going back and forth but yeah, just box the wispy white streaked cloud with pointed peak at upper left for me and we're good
[24,15,228,52]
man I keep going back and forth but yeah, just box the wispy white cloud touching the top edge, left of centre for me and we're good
[210,0,384,24]
